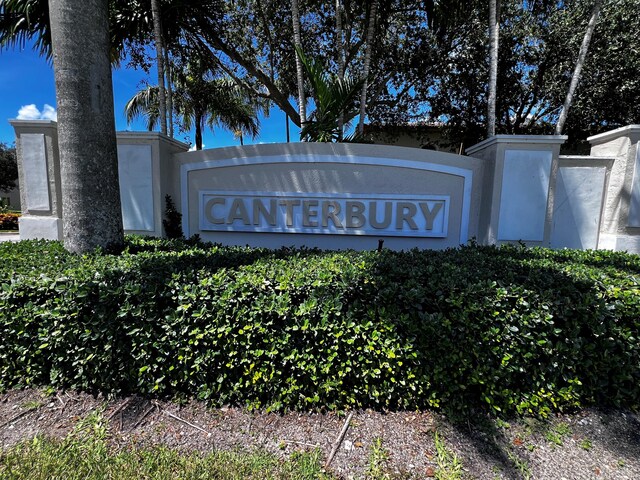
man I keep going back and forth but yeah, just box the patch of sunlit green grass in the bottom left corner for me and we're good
[0,414,332,480]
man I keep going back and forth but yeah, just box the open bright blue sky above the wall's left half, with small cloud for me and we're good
[0,48,299,148]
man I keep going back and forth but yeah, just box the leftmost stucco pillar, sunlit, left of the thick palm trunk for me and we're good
[10,120,62,240]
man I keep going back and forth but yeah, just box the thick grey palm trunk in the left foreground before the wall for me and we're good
[49,0,124,253]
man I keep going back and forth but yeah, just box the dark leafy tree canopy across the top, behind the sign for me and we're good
[0,0,640,145]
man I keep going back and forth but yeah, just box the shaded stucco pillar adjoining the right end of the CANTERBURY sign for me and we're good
[467,135,567,246]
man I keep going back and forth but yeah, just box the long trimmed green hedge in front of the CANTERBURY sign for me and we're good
[0,237,640,414]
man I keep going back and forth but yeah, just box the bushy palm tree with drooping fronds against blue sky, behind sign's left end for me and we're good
[125,61,261,150]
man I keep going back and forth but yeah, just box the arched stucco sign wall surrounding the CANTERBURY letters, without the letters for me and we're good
[176,144,481,249]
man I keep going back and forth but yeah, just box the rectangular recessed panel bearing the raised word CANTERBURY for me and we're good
[199,190,450,238]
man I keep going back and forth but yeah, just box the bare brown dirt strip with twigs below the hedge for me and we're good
[0,389,640,480]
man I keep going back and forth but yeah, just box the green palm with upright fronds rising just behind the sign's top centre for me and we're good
[296,50,364,142]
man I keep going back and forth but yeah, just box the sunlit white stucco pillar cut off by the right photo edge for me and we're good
[587,125,640,253]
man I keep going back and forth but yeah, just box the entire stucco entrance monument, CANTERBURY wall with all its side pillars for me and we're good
[11,120,640,253]
